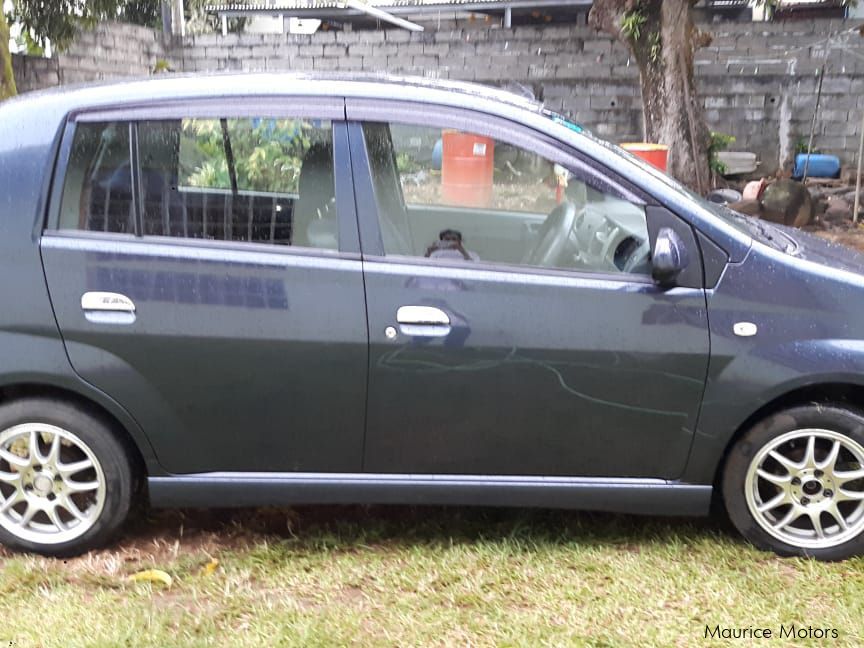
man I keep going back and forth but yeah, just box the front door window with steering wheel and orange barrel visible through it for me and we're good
[364,123,651,274]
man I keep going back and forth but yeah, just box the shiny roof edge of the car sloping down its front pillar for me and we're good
[0,72,750,258]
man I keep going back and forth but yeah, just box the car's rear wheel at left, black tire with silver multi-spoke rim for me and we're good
[0,398,134,557]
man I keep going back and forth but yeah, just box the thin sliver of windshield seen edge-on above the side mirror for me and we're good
[543,110,797,254]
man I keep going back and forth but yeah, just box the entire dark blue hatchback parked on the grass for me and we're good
[0,74,864,560]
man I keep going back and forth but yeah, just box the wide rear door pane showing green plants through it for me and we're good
[138,118,338,250]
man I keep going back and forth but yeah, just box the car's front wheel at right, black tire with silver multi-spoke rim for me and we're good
[722,404,864,561]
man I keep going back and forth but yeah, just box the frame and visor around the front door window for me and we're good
[346,103,660,284]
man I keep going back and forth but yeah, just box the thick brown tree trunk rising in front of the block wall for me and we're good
[589,0,710,194]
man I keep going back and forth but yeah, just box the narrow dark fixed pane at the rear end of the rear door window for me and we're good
[60,122,135,234]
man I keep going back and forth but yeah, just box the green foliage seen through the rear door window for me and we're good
[179,119,321,193]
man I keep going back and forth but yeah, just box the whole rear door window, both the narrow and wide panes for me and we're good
[60,117,338,250]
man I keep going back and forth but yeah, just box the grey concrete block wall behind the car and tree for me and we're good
[15,20,864,173]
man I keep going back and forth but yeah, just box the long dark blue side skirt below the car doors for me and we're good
[147,472,712,515]
